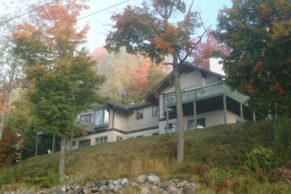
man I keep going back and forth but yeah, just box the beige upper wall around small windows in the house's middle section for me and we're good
[127,106,159,131]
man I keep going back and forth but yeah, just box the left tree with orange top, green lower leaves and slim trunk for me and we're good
[13,1,102,181]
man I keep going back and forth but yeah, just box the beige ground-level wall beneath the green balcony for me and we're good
[159,110,240,134]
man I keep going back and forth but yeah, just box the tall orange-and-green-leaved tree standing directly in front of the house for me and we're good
[105,0,207,163]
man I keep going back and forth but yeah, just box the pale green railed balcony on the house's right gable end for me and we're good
[165,83,248,107]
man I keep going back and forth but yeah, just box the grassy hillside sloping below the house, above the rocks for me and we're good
[0,122,291,193]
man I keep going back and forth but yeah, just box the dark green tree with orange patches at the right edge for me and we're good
[215,0,291,116]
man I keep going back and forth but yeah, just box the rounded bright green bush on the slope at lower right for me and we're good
[245,147,277,172]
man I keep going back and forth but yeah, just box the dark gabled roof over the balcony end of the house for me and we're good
[145,62,225,104]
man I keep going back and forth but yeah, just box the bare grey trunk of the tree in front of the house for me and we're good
[173,53,184,164]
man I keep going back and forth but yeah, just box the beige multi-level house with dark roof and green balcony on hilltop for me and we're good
[70,63,255,149]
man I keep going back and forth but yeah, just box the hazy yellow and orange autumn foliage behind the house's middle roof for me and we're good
[91,48,169,104]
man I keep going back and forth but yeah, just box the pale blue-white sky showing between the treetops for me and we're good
[0,0,231,51]
